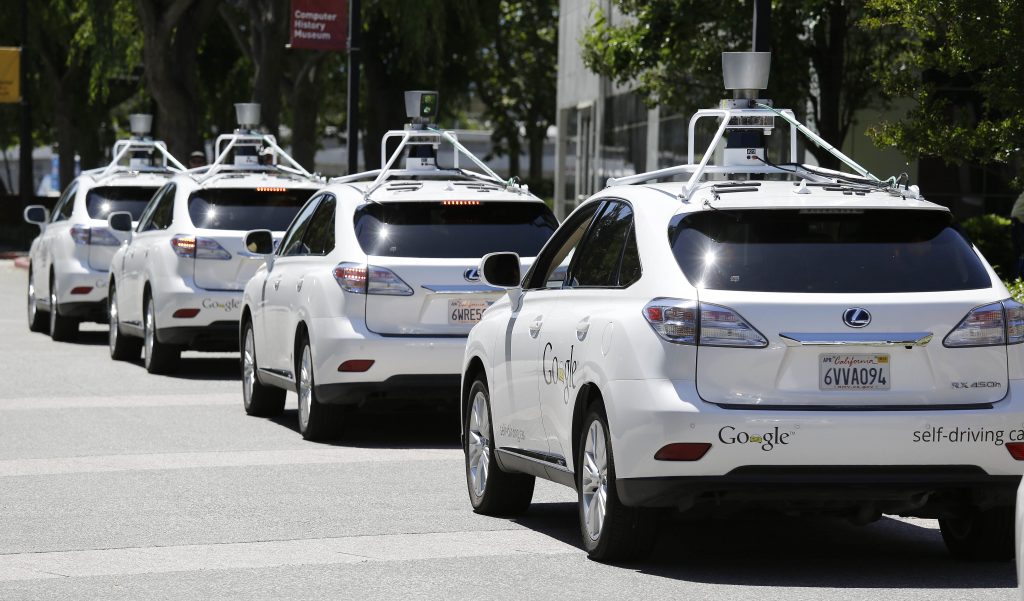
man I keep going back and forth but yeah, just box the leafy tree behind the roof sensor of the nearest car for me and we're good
[583,0,893,167]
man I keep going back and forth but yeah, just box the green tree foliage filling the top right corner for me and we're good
[867,0,1024,180]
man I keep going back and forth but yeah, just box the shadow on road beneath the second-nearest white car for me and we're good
[270,407,460,448]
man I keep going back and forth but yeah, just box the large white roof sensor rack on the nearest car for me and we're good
[607,52,920,202]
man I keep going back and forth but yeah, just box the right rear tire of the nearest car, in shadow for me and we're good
[939,507,1015,561]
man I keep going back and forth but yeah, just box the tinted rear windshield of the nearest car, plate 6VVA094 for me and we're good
[669,209,992,293]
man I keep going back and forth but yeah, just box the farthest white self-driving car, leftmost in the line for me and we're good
[25,115,185,340]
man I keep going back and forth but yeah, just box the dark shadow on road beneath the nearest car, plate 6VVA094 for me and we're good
[514,503,1017,589]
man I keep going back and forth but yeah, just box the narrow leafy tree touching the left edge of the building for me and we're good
[476,0,558,185]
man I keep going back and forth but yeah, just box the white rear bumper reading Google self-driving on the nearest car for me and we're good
[602,380,1024,489]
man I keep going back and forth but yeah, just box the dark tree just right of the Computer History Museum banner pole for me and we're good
[361,0,497,169]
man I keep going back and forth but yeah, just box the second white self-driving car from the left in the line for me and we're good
[108,104,322,373]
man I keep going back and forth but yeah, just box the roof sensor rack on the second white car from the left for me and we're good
[188,102,323,182]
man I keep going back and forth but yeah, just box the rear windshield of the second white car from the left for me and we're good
[188,187,314,231]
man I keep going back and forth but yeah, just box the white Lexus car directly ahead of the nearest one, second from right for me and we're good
[241,95,558,439]
